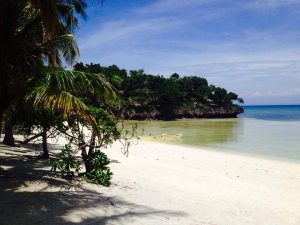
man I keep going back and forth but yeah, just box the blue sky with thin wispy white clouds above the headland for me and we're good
[76,0,300,104]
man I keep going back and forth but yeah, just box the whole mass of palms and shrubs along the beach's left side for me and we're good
[0,0,126,186]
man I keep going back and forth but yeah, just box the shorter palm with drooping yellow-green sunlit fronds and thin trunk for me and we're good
[25,70,115,158]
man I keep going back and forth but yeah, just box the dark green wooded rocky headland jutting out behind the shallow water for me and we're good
[74,63,243,120]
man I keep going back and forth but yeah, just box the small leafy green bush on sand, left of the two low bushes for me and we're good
[51,144,80,180]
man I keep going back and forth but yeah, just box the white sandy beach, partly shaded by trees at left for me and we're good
[0,141,300,225]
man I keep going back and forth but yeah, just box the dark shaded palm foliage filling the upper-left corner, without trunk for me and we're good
[0,0,86,144]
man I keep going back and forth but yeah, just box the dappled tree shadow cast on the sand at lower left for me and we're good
[0,145,185,225]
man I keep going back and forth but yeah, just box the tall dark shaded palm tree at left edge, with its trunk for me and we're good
[0,0,79,145]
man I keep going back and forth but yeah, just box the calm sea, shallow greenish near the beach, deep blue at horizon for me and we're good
[126,105,300,163]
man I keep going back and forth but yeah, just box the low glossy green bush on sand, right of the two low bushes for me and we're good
[84,151,113,187]
